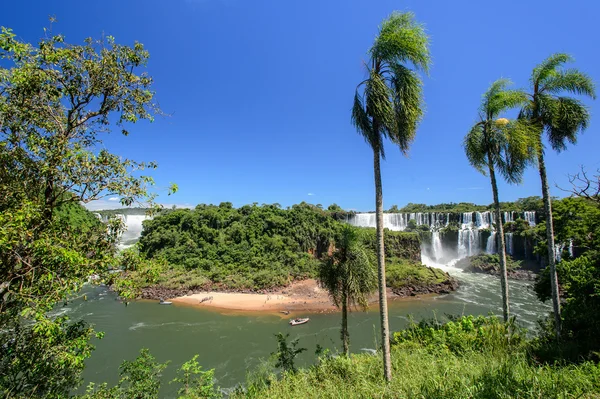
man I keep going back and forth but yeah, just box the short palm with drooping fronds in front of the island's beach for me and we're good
[319,226,377,356]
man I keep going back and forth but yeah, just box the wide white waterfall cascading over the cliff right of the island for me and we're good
[346,211,540,260]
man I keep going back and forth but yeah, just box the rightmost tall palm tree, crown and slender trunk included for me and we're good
[519,54,596,338]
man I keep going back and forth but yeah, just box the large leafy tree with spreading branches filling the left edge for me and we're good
[0,28,168,397]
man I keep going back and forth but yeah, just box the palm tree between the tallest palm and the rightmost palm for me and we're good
[464,79,535,322]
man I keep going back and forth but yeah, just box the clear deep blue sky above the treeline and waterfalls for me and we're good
[0,0,600,210]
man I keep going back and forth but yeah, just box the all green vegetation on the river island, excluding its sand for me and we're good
[113,203,432,296]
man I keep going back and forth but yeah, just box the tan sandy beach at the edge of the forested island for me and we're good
[169,280,336,311]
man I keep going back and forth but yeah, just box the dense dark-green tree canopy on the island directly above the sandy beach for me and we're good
[139,203,342,289]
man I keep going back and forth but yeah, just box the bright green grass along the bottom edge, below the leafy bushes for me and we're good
[233,347,600,399]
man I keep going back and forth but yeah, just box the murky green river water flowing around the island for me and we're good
[56,265,549,398]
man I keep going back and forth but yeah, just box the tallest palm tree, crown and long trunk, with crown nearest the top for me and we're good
[352,13,430,381]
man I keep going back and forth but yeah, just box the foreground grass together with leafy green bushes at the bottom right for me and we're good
[231,316,600,399]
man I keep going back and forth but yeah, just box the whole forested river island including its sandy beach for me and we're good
[109,203,457,310]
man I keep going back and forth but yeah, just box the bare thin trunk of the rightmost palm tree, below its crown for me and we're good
[538,150,561,338]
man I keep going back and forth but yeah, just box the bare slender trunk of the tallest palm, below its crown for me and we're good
[373,148,392,382]
